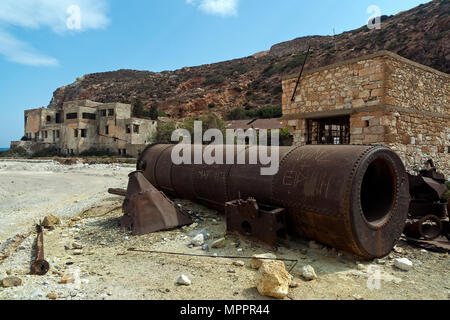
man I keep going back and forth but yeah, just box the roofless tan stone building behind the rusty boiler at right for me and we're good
[282,51,450,176]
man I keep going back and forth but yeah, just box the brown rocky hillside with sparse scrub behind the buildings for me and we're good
[50,0,450,118]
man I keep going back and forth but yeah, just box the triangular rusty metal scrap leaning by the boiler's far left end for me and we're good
[120,171,192,235]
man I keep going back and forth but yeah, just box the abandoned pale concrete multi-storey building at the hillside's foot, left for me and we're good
[19,100,157,156]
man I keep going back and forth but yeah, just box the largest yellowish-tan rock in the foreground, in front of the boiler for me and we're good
[256,261,291,299]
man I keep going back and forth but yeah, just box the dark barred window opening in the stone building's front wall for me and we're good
[306,116,350,144]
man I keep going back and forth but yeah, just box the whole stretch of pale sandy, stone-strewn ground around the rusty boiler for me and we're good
[0,163,450,300]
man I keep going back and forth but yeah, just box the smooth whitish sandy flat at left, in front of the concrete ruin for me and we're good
[0,161,134,242]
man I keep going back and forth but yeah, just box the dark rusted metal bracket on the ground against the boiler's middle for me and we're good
[225,198,287,248]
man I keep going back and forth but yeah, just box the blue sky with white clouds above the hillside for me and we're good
[0,0,427,147]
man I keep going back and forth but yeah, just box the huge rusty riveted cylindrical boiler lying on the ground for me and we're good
[137,144,410,259]
